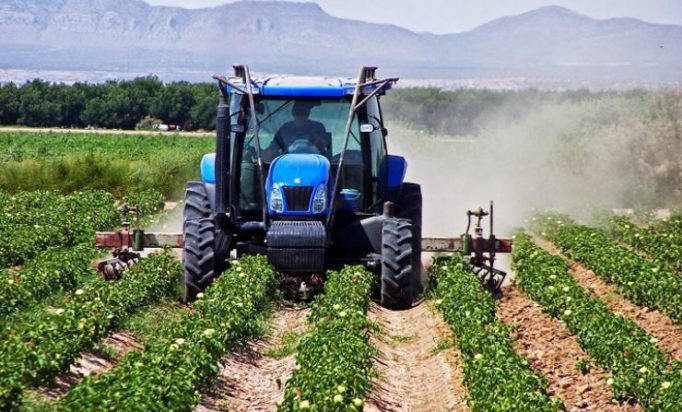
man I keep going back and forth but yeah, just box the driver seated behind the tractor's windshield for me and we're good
[265,101,330,157]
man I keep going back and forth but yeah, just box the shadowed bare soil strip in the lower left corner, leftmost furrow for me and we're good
[37,332,144,400]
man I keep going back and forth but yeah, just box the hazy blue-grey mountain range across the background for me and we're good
[0,0,682,82]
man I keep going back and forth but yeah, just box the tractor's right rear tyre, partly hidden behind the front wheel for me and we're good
[395,183,424,298]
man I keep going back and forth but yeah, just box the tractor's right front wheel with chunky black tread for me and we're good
[381,218,414,309]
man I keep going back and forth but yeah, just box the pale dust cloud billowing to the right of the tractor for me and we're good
[387,97,644,236]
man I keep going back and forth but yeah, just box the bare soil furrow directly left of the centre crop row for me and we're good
[195,307,310,412]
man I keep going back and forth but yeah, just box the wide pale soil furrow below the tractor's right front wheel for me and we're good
[365,304,468,412]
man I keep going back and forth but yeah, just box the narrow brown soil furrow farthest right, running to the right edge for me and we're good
[535,238,682,361]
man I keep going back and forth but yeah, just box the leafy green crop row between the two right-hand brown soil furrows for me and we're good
[512,234,682,410]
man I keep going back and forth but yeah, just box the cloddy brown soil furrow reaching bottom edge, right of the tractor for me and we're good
[497,287,642,411]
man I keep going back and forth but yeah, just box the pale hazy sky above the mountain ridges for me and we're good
[145,0,682,33]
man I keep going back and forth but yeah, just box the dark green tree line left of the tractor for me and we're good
[0,76,218,130]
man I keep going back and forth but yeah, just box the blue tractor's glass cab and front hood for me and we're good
[220,77,390,221]
